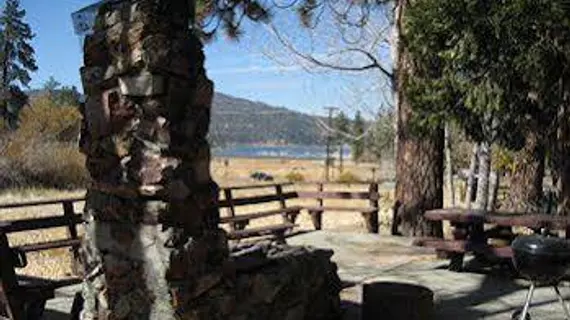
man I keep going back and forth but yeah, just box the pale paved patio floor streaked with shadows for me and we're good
[46,231,570,320]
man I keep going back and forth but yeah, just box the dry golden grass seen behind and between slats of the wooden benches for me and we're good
[0,158,393,278]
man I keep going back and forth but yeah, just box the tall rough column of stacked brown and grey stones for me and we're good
[80,0,231,320]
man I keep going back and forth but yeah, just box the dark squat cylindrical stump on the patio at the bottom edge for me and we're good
[361,282,434,320]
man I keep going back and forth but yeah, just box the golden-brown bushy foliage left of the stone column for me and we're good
[0,95,88,189]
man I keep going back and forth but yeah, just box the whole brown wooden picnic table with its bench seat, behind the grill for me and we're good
[414,208,570,271]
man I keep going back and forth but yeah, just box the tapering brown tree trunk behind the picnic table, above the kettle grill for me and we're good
[505,132,545,213]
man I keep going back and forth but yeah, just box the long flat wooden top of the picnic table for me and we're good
[424,208,570,229]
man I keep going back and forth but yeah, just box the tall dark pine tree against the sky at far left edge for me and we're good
[0,0,38,128]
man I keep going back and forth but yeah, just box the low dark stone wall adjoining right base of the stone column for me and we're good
[184,245,341,320]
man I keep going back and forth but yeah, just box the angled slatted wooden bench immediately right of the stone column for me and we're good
[219,183,302,242]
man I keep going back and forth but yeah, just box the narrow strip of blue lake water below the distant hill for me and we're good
[212,145,350,159]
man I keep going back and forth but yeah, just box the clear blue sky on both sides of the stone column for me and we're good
[11,0,388,117]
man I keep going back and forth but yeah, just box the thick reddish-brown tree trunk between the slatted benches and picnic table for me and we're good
[394,0,444,237]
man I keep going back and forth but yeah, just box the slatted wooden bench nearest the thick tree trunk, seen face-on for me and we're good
[297,183,380,233]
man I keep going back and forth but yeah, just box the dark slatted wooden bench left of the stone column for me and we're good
[0,198,83,320]
